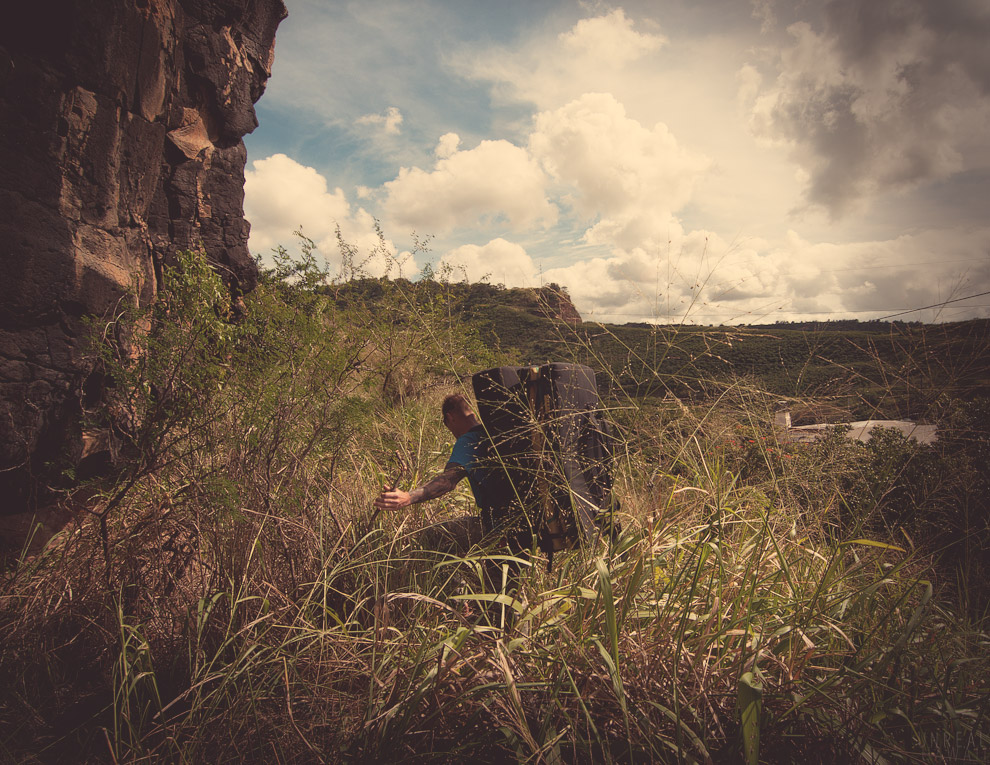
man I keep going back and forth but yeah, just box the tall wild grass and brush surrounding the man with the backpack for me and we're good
[0,248,990,763]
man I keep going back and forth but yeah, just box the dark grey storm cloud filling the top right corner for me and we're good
[751,0,990,217]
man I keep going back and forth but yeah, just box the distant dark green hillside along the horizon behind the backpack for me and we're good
[332,279,990,420]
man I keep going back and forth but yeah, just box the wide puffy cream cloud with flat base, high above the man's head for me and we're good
[385,134,557,233]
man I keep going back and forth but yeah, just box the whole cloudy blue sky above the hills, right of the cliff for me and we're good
[244,0,990,324]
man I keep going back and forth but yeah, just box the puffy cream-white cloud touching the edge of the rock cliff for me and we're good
[244,154,402,276]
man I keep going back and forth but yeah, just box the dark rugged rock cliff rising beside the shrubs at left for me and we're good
[0,0,286,513]
